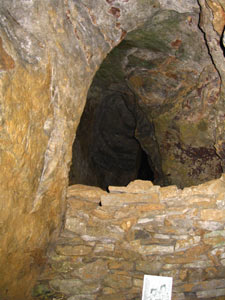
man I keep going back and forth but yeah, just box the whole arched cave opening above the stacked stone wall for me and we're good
[70,11,222,189]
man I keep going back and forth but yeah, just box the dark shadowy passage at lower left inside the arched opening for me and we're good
[70,87,157,190]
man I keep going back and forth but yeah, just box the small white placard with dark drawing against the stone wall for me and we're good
[142,275,173,300]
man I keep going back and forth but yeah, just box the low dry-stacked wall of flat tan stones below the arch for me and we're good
[34,174,225,300]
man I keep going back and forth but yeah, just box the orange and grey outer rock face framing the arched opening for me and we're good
[0,0,225,300]
